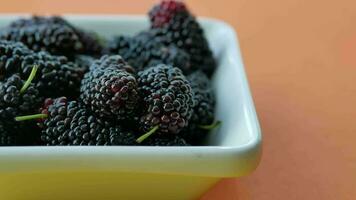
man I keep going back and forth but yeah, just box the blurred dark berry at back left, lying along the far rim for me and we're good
[0,16,101,58]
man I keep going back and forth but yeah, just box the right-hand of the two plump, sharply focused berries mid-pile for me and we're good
[138,64,194,135]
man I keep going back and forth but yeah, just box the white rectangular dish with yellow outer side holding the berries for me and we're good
[0,15,261,200]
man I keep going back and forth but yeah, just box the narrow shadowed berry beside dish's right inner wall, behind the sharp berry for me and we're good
[182,71,215,144]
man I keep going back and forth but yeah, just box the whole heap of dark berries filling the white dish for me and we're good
[0,0,219,146]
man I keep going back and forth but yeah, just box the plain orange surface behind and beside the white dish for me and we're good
[0,0,356,200]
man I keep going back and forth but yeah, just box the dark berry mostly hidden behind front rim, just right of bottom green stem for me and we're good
[142,136,190,146]
